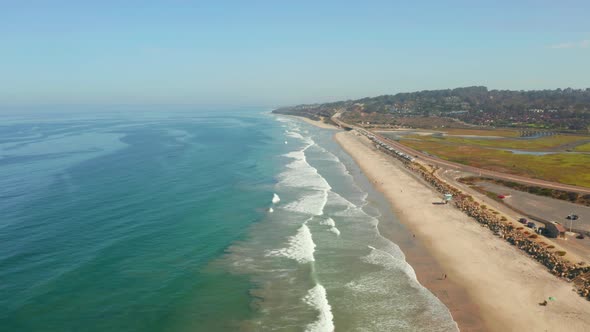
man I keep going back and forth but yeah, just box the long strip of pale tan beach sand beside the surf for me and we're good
[335,132,590,331]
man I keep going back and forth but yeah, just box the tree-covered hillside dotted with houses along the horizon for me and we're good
[276,86,590,132]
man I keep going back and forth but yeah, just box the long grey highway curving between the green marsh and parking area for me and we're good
[332,113,590,194]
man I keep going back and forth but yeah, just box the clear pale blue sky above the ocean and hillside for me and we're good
[0,0,590,106]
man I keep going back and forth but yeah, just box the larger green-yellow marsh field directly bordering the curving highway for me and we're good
[400,136,590,187]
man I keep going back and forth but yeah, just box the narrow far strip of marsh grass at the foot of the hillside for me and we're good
[407,131,590,151]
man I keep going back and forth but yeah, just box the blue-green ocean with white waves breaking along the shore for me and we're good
[0,107,457,331]
